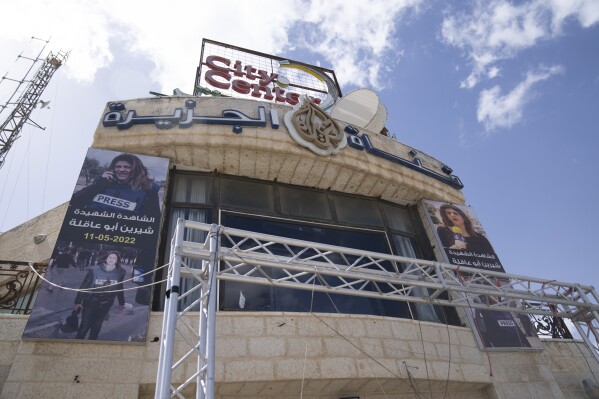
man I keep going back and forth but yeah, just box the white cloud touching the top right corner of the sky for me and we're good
[442,0,599,88]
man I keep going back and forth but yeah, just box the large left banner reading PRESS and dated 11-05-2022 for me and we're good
[23,148,169,342]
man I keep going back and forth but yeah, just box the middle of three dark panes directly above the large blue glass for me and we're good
[279,187,331,220]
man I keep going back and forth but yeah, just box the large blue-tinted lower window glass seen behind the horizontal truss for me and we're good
[219,214,410,318]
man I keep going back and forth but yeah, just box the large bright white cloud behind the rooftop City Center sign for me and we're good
[0,0,421,94]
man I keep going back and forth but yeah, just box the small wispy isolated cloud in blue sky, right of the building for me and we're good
[477,66,564,134]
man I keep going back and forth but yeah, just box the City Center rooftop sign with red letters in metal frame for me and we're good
[194,39,341,109]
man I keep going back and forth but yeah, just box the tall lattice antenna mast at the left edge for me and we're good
[0,37,69,168]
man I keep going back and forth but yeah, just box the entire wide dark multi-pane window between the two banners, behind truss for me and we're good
[155,173,462,322]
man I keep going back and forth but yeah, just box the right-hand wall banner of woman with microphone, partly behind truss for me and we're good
[422,200,542,349]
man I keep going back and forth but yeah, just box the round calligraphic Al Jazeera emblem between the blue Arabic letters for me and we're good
[284,96,347,156]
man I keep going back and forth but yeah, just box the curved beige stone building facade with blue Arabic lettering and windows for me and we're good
[0,97,599,399]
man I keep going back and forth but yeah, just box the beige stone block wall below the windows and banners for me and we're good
[0,312,599,399]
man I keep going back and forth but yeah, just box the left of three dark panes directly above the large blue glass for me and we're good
[220,178,275,212]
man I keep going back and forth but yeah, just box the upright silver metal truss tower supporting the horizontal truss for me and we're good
[155,223,220,399]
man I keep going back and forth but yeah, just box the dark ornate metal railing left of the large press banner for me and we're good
[0,260,47,314]
